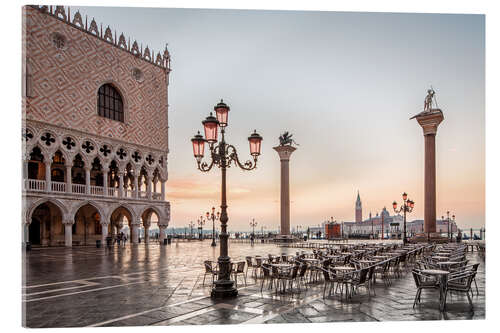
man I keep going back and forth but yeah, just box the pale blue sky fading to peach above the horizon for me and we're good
[72,7,485,231]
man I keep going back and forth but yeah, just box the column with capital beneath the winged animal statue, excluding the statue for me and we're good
[273,146,297,236]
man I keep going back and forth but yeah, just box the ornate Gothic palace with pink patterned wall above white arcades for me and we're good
[22,6,170,246]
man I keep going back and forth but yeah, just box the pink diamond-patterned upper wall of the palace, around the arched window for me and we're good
[23,6,170,152]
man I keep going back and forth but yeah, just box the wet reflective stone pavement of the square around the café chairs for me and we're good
[22,240,485,327]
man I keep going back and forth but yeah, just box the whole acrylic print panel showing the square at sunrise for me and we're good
[22,5,486,327]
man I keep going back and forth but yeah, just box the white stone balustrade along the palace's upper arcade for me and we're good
[23,179,165,201]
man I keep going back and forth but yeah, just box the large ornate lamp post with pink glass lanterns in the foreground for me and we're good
[191,100,262,298]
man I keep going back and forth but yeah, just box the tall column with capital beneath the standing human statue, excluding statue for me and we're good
[412,109,444,235]
